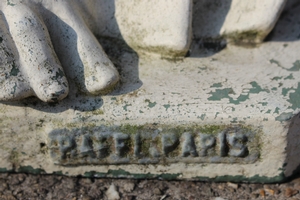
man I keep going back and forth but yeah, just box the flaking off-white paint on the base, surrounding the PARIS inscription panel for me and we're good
[0,34,300,181]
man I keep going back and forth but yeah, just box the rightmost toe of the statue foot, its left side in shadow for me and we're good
[39,1,119,94]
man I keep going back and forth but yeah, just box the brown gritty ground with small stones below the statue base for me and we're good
[0,173,300,200]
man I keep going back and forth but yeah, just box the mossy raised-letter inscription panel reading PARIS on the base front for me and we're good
[49,125,259,165]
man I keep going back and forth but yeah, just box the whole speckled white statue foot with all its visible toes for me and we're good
[0,1,119,102]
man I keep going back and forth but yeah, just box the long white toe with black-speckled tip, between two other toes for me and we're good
[4,4,69,102]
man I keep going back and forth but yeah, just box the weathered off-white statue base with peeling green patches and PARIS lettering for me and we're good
[0,35,300,182]
